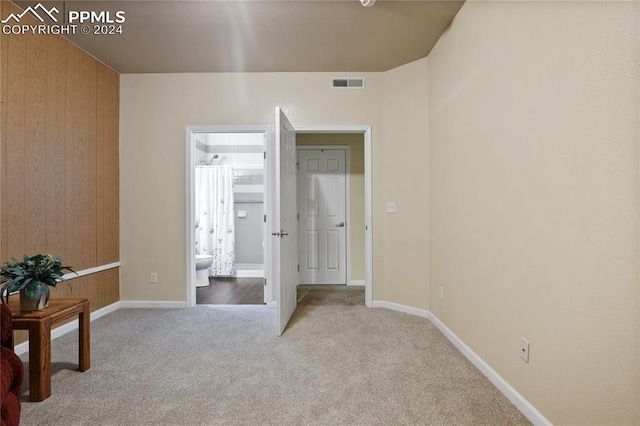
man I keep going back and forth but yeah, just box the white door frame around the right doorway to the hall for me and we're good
[294,125,373,308]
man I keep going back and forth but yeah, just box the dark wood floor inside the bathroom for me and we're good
[196,278,264,305]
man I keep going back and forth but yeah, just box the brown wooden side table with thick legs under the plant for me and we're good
[9,297,91,401]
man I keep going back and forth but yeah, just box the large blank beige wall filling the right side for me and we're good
[424,1,640,425]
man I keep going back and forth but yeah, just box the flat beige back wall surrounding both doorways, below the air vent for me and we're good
[120,73,384,301]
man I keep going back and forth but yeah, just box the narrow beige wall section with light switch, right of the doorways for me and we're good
[374,58,429,309]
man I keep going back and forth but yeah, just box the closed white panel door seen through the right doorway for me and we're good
[298,149,347,284]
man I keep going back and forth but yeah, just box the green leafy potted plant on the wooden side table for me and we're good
[0,254,75,312]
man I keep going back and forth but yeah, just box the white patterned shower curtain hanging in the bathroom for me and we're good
[195,166,236,276]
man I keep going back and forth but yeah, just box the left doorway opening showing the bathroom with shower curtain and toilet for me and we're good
[187,126,270,304]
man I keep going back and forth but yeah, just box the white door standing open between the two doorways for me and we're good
[271,107,298,336]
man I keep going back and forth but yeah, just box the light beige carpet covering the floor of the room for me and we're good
[21,296,528,426]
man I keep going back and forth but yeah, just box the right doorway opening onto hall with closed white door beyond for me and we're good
[297,133,365,286]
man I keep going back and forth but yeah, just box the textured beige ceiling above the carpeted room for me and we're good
[16,0,463,73]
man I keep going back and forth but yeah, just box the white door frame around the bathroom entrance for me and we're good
[185,125,272,307]
